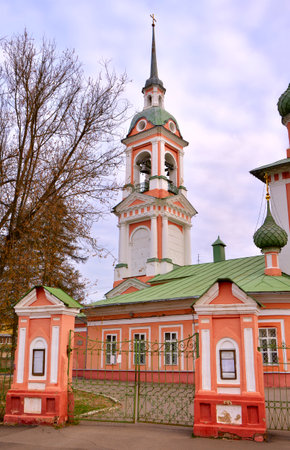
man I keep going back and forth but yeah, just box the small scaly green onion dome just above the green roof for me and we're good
[254,202,288,250]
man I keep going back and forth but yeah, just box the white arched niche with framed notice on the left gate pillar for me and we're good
[29,337,47,380]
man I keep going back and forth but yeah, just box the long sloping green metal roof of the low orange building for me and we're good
[85,255,290,308]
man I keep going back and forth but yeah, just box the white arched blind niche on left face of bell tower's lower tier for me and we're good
[130,227,150,276]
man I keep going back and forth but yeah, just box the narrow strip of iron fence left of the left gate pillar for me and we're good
[0,345,14,421]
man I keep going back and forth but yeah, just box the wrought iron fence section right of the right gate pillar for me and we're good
[259,337,290,431]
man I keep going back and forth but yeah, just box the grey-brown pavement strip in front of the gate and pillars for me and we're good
[0,421,290,450]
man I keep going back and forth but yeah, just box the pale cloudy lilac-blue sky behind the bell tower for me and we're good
[0,0,290,300]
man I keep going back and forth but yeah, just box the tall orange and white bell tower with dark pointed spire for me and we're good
[113,16,196,285]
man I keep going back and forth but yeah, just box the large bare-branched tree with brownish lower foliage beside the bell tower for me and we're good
[0,31,127,326]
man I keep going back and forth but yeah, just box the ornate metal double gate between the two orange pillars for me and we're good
[69,333,198,426]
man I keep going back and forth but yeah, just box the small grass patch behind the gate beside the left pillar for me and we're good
[74,390,116,416]
